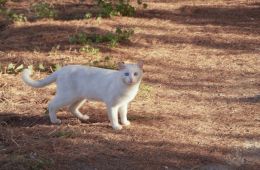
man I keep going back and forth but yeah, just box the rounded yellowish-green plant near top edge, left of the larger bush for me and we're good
[32,2,57,18]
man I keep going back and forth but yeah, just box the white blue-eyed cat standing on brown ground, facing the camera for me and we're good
[22,62,143,130]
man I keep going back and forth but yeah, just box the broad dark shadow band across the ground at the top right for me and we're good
[137,4,260,27]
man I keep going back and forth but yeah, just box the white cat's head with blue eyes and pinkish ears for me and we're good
[118,61,143,85]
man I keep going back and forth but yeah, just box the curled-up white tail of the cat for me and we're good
[22,69,57,88]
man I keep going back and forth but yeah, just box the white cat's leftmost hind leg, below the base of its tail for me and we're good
[48,95,73,124]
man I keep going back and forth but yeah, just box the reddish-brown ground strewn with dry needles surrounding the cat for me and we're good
[0,0,260,170]
